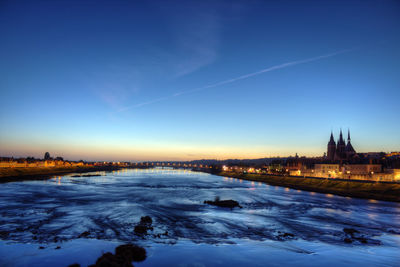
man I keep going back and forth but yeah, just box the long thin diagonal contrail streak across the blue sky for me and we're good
[119,48,355,112]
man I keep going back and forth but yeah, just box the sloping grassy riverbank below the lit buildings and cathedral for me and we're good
[208,171,400,202]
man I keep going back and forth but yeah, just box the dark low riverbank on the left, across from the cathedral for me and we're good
[0,166,121,183]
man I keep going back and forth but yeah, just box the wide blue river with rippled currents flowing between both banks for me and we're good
[0,169,400,266]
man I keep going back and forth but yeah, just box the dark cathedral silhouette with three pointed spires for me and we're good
[327,130,356,160]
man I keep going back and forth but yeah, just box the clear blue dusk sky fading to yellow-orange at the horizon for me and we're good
[0,0,400,161]
